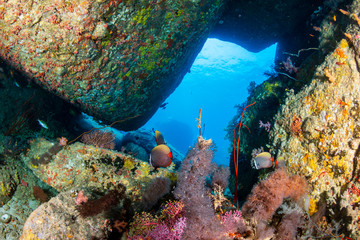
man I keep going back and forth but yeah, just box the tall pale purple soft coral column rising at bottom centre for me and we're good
[174,136,224,240]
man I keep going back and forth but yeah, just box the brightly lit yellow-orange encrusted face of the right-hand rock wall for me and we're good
[270,1,360,239]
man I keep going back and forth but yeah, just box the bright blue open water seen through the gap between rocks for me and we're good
[144,38,276,165]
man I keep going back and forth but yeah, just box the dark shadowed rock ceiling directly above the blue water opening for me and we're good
[210,0,321,52]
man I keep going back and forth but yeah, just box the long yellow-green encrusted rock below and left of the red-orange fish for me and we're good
[23,139,176,206]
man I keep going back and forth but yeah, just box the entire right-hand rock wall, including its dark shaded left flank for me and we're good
[225,1,360,236]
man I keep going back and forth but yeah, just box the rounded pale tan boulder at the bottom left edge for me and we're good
[20,191,110,240]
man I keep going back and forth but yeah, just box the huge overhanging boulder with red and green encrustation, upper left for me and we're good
[0,0,224,130]
